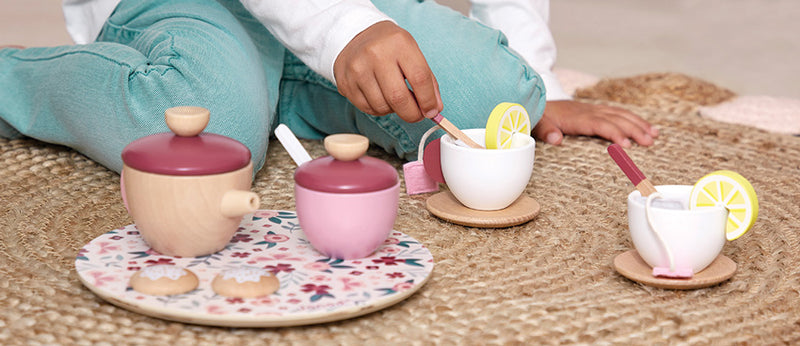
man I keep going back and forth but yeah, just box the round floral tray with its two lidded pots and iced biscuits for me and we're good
[75,107,434,327]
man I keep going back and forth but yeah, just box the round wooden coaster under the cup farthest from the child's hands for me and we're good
[614,250,736,290]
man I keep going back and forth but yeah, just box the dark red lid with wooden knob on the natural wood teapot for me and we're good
[122,106,250,175]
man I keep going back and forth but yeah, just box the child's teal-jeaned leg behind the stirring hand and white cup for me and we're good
[278,0,545,160]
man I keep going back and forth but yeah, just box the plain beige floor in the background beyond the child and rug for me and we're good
[0,0,800,98]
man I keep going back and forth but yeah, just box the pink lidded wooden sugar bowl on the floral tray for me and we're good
[294,134,400,259]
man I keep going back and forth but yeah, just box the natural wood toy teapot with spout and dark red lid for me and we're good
[121,106,260,257]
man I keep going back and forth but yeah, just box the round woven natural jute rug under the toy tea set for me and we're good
[0,74,800,345]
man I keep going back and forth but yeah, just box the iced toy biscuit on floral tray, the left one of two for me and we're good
[130,264,199,296]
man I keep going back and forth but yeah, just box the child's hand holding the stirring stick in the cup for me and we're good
[333,22,442,122]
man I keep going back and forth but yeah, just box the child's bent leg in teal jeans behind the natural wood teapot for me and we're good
[0,0,283,171]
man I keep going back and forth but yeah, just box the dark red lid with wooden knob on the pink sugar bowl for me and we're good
[294,134,399,193]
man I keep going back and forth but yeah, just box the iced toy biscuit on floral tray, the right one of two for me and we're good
[211,267,280,298]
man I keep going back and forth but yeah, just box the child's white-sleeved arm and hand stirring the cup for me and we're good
[241,0,442,122]
